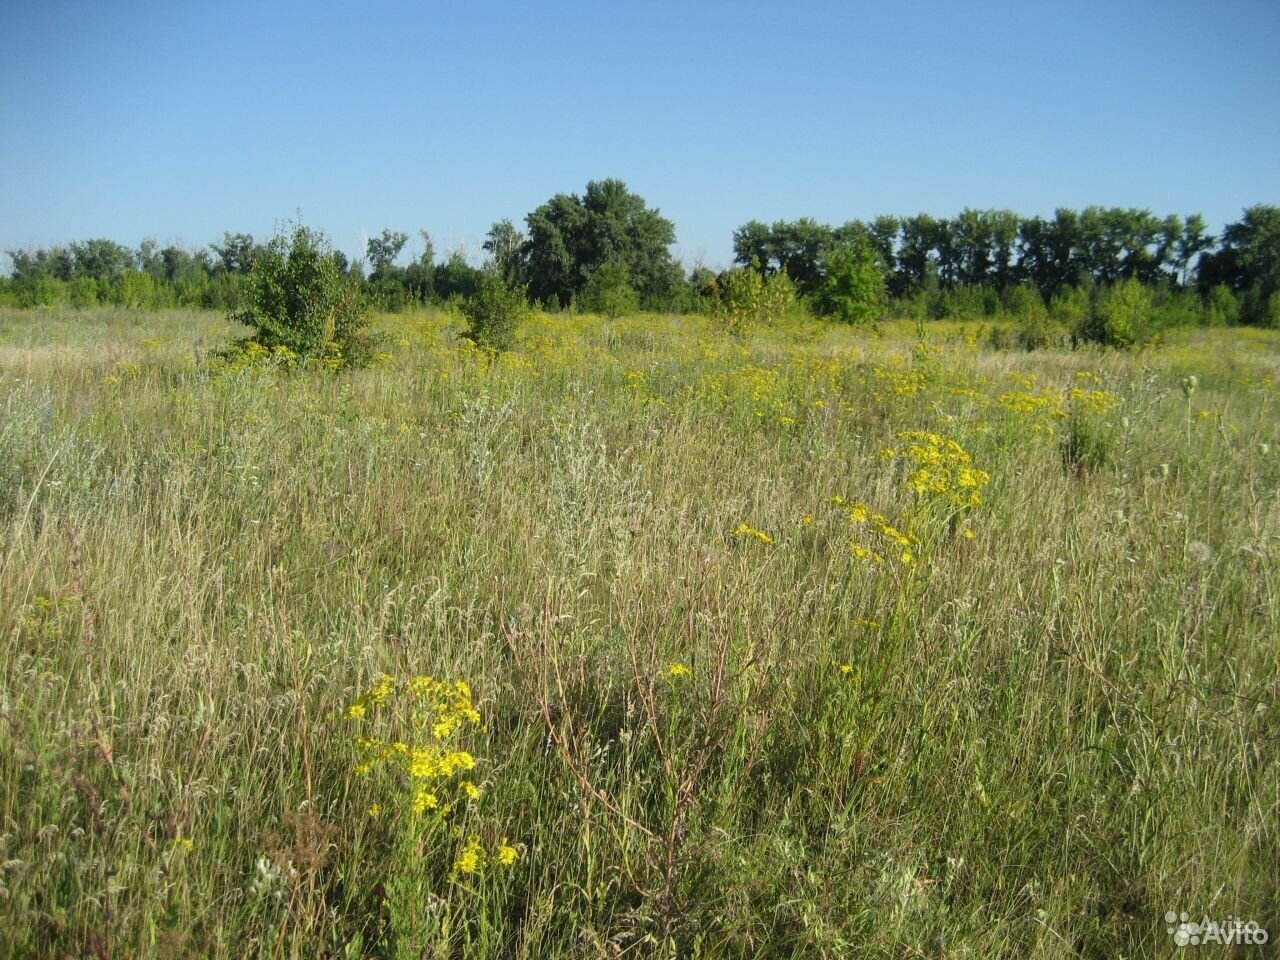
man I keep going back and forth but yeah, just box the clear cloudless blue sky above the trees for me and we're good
[0,0,1280,266]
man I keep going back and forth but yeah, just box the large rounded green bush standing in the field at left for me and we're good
[232,224,369,364]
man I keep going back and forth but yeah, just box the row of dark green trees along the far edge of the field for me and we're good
[0,179,1280,325]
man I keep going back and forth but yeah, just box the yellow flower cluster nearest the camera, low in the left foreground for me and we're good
[346,675,480,817]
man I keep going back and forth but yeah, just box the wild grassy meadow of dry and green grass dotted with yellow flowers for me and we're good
[0,311,1280,960]
